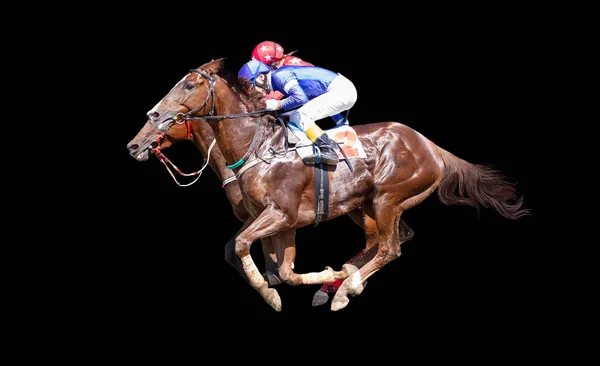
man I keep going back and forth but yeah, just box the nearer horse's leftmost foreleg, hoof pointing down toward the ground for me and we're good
[235,205,292,311]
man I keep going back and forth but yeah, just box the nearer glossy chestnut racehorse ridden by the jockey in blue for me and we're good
[142,58,530,311]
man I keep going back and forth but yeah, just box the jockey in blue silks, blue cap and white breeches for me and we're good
[238,59,357,165]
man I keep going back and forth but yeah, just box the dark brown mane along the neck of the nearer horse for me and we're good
[199,58,266,111]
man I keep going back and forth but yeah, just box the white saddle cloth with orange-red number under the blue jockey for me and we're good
[288,123,367,160]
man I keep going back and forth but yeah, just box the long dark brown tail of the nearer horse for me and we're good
[437,147,530,220]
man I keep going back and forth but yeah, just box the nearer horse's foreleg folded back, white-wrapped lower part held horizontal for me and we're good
[271,229,351,286]
